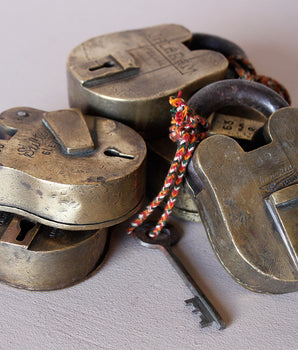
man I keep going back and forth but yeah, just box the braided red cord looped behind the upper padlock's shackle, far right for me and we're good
[229,55,291,105]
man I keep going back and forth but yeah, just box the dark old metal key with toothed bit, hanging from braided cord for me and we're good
[134,223,226,329]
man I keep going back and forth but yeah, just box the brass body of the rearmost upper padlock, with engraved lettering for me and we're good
[67,24,228,138]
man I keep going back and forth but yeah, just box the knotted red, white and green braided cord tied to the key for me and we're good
[127,91,208,237]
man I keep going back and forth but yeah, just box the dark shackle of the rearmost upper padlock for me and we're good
[187,33,247,58]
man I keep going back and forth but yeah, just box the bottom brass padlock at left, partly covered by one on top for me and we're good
[0,212,109,290]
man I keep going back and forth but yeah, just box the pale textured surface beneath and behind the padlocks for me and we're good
[0,0,298,350]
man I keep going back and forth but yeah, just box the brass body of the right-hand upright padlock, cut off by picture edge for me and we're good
[187,98,298,293]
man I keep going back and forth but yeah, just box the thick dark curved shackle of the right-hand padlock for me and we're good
[187,79,289,118]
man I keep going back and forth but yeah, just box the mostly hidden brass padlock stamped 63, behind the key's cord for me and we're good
[147,106,267,222]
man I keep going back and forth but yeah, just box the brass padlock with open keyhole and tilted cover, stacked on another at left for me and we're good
[0,107,146,230]
